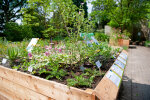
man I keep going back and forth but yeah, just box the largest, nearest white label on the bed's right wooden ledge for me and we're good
[106,70,121,87]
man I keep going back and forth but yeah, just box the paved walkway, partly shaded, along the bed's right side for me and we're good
[118,46,150,100]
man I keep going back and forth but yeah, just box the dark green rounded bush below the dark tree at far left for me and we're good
[4,22,34,41]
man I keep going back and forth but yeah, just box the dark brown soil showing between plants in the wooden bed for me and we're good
[0,55,115,90]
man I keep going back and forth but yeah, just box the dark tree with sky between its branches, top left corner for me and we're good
[0,0,26,36]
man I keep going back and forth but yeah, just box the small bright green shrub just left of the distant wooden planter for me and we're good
[95,32,109,42]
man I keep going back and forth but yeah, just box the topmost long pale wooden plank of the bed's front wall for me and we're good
[0,66,93,100]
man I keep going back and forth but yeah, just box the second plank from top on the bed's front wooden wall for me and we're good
[0,77,50,100]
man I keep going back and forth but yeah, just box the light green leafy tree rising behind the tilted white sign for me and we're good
[21,5,47,37]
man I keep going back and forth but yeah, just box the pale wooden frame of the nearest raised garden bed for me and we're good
[0,51,127,100]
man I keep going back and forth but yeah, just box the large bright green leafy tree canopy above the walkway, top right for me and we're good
[93,0,149,33]
